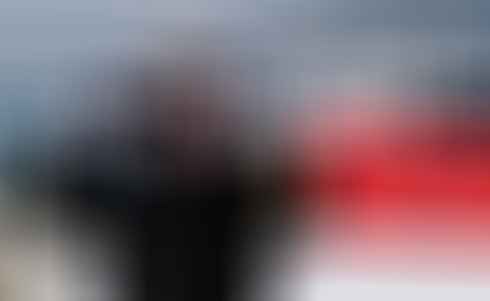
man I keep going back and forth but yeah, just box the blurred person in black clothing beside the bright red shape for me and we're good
[52,57,250,301]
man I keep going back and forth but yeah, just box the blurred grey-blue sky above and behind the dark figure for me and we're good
[0,0,490,172]
